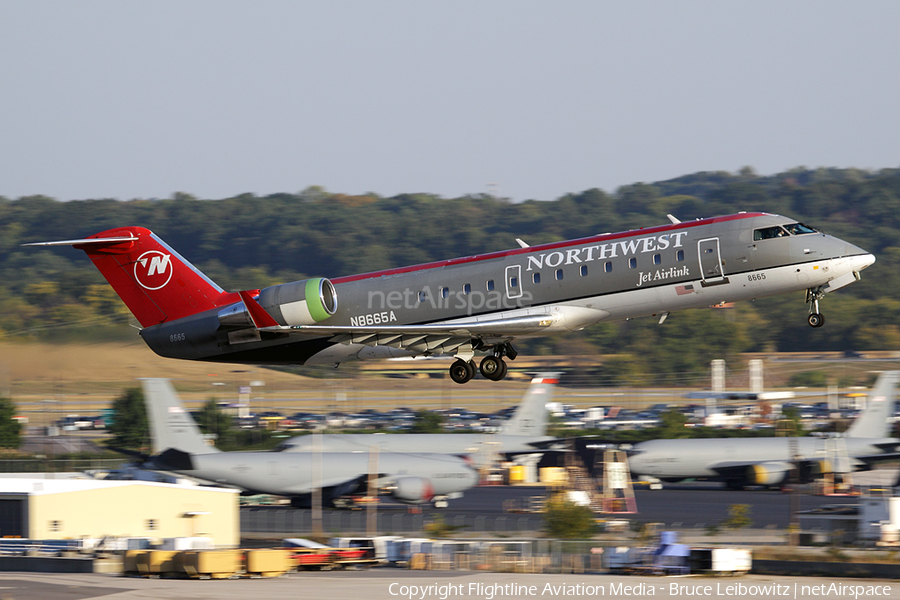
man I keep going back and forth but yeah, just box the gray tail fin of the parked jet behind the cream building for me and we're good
[141,379,218,454]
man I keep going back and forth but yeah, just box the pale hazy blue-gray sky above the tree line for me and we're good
[0,0,900,200]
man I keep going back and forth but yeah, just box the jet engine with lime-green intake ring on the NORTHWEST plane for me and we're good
[257,277,337,325]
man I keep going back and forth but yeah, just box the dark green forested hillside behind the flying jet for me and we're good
[0,169,900,379]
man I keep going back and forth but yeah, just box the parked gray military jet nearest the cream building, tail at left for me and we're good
[143,379,478,507]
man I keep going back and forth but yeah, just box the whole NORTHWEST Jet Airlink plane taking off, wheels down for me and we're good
[28,213,875,383]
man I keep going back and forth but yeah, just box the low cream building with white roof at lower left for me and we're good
[0,479,240,547]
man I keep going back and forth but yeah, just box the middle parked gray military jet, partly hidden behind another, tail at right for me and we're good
[278,373,559,467]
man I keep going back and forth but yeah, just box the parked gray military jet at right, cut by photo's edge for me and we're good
[628,371,900,488]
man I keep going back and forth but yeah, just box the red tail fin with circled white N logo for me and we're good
[72,227,234,327]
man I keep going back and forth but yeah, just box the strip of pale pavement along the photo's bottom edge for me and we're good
[0,568,900,600]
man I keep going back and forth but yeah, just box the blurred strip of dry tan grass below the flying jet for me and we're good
[0,336,900,424]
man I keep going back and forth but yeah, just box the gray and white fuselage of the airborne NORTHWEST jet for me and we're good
[141,213,874,364]
